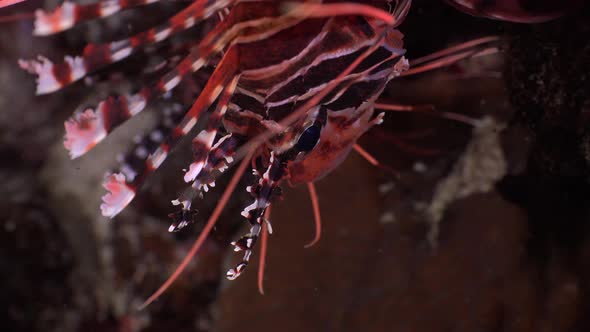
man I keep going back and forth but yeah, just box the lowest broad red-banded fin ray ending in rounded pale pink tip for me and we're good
[101,48,237,218]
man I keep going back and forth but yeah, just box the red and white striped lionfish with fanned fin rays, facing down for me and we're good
[9,0,497,306]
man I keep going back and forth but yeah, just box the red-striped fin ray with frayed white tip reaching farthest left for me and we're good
[19,0,235,95]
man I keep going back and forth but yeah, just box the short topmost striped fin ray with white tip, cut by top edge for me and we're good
[33,0,160,36]
